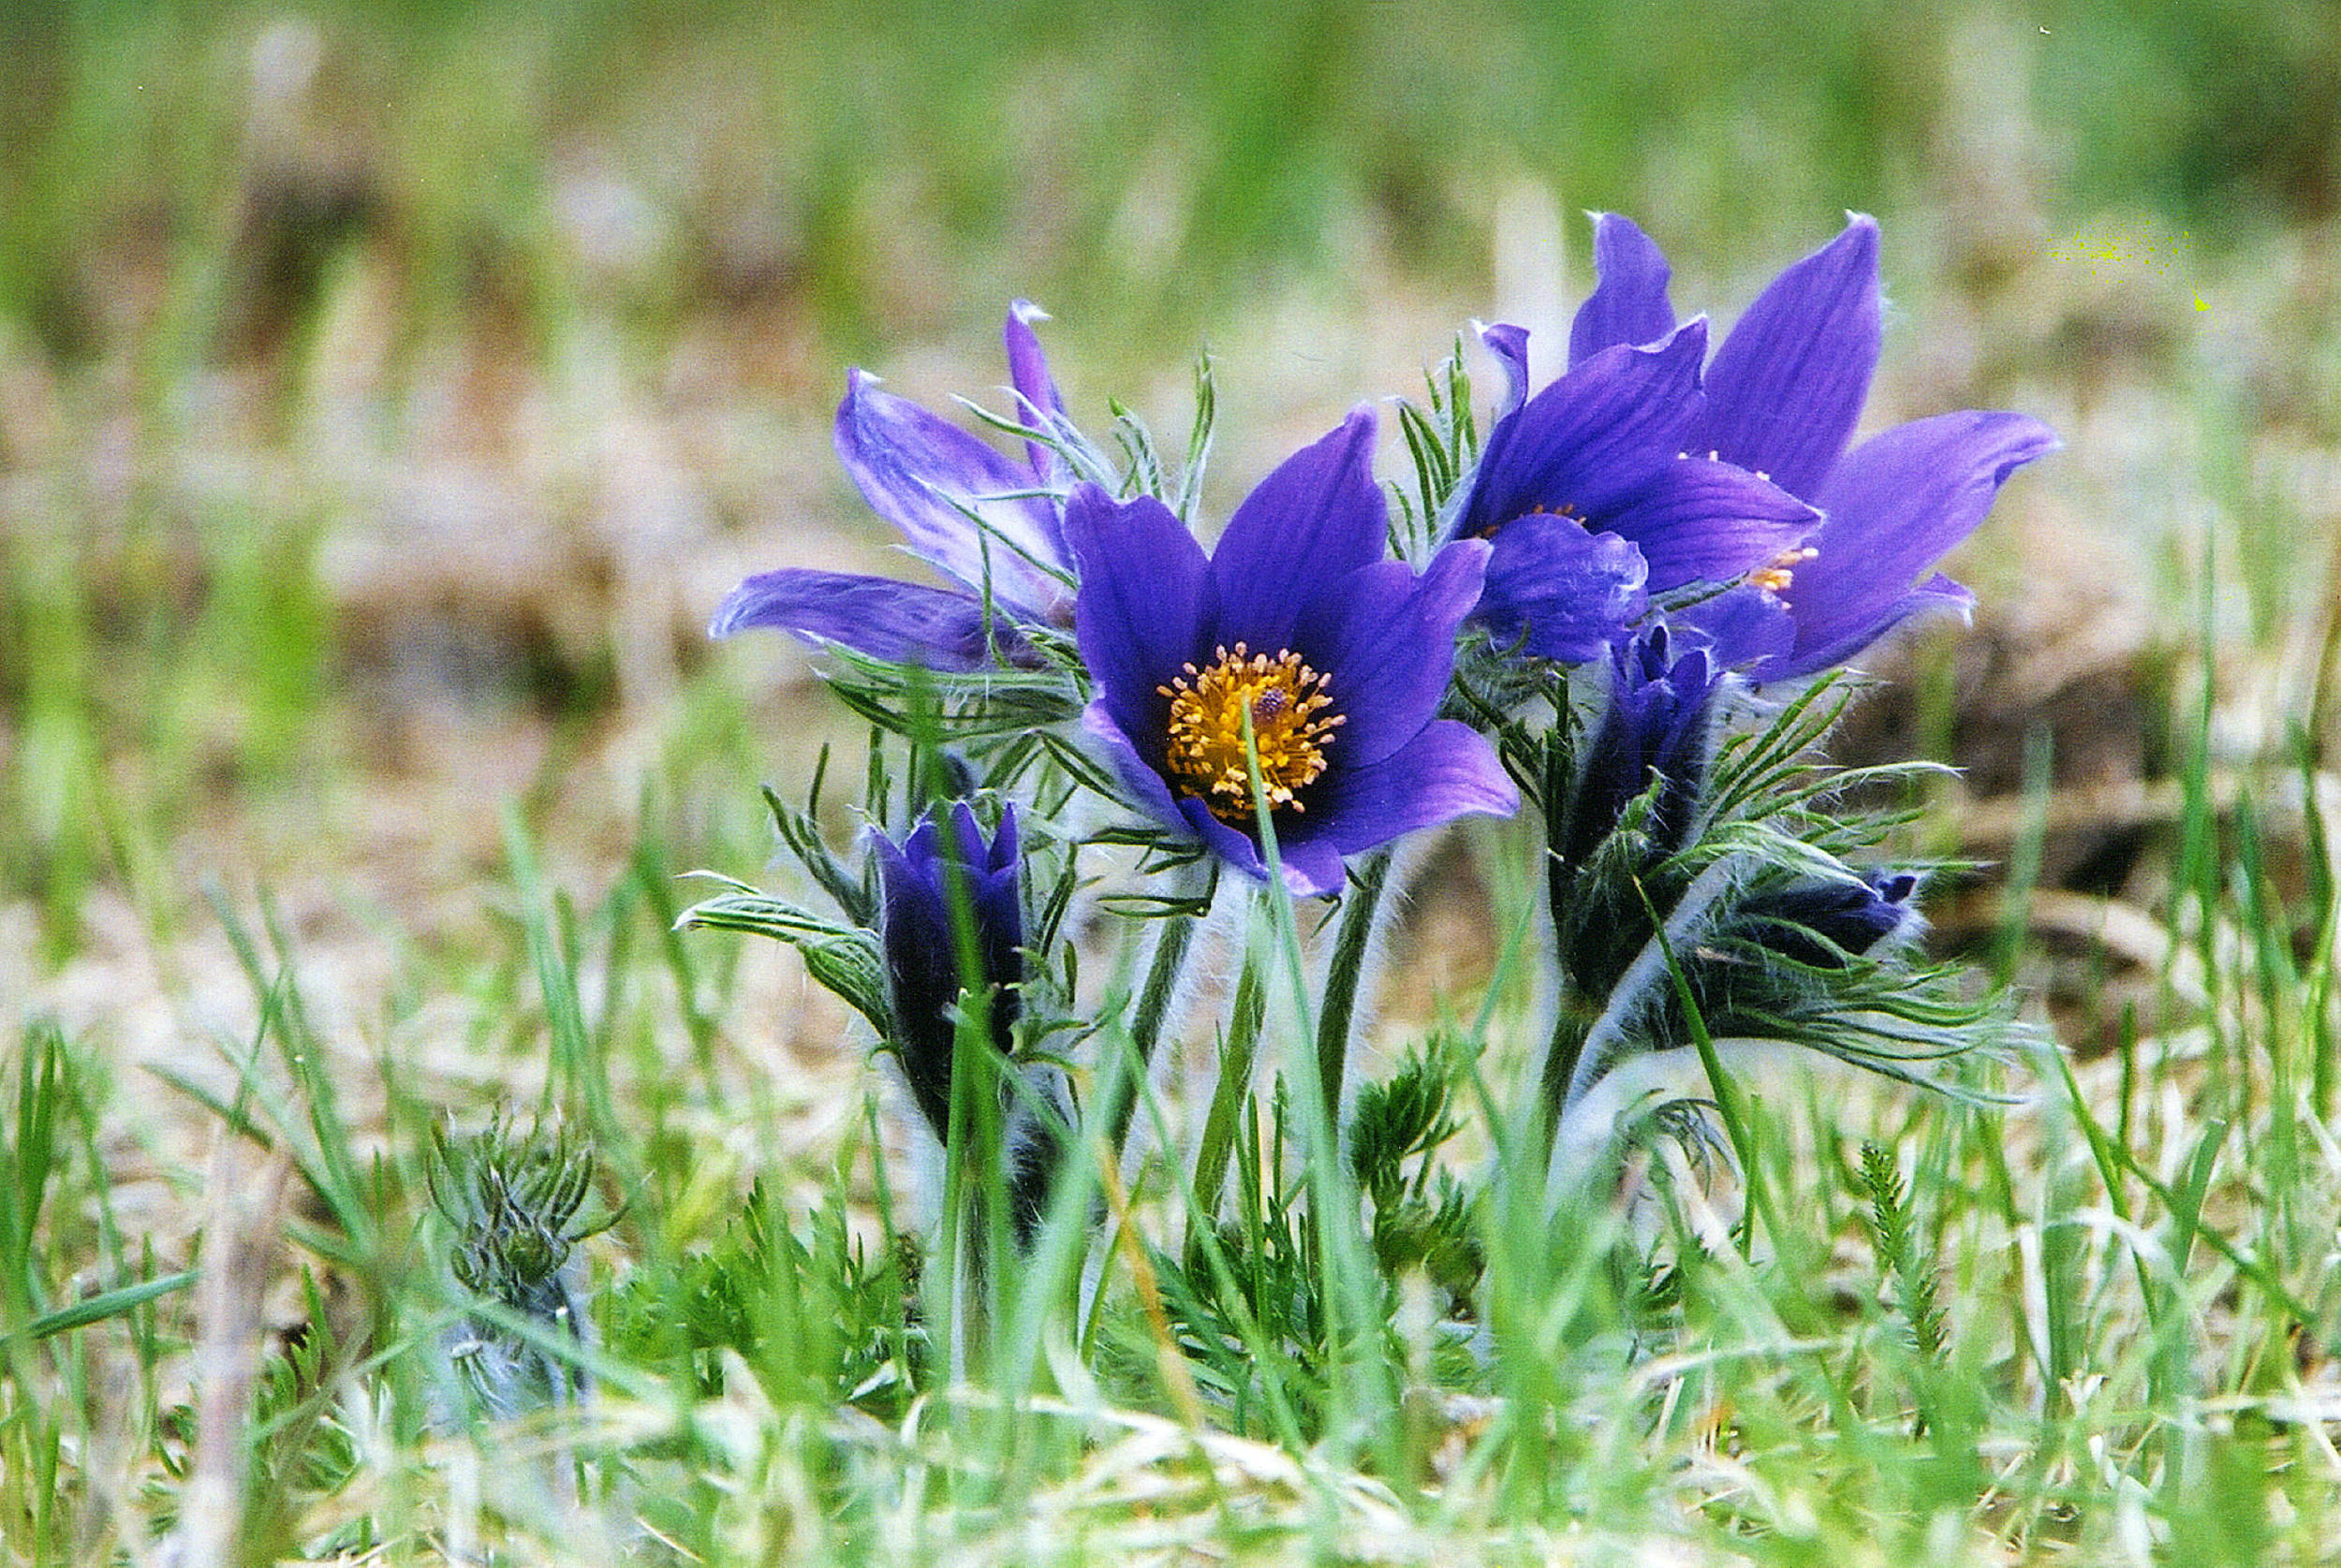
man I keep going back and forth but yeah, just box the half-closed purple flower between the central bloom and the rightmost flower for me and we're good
[1454,316,1819,663]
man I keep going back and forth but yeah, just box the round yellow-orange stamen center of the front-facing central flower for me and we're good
[1155,644,1347,822]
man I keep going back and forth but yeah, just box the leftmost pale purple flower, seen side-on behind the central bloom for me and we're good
[707,300,1072,672]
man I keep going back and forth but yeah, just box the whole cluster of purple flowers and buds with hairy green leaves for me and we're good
[702,215,2055,1273]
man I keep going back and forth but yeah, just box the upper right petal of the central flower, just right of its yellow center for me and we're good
[1295,538,1492,768]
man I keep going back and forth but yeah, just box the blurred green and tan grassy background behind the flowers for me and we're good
[0,0,2341,962]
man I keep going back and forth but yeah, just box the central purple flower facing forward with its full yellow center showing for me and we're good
[1066,410,1520,894]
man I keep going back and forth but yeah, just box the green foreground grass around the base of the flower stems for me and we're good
[0,623,2341,1563]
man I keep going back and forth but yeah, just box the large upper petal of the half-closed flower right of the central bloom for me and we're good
[1456,321,1707,536]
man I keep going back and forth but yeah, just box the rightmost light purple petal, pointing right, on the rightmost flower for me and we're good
[1768,410,2060,674]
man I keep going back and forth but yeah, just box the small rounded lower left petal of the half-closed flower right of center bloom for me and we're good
[1473,515,1651,665]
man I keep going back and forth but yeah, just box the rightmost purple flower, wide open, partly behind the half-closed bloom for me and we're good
[1564,213,2060,681]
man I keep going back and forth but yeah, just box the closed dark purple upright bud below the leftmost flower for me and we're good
[871,800,1023,1140]
